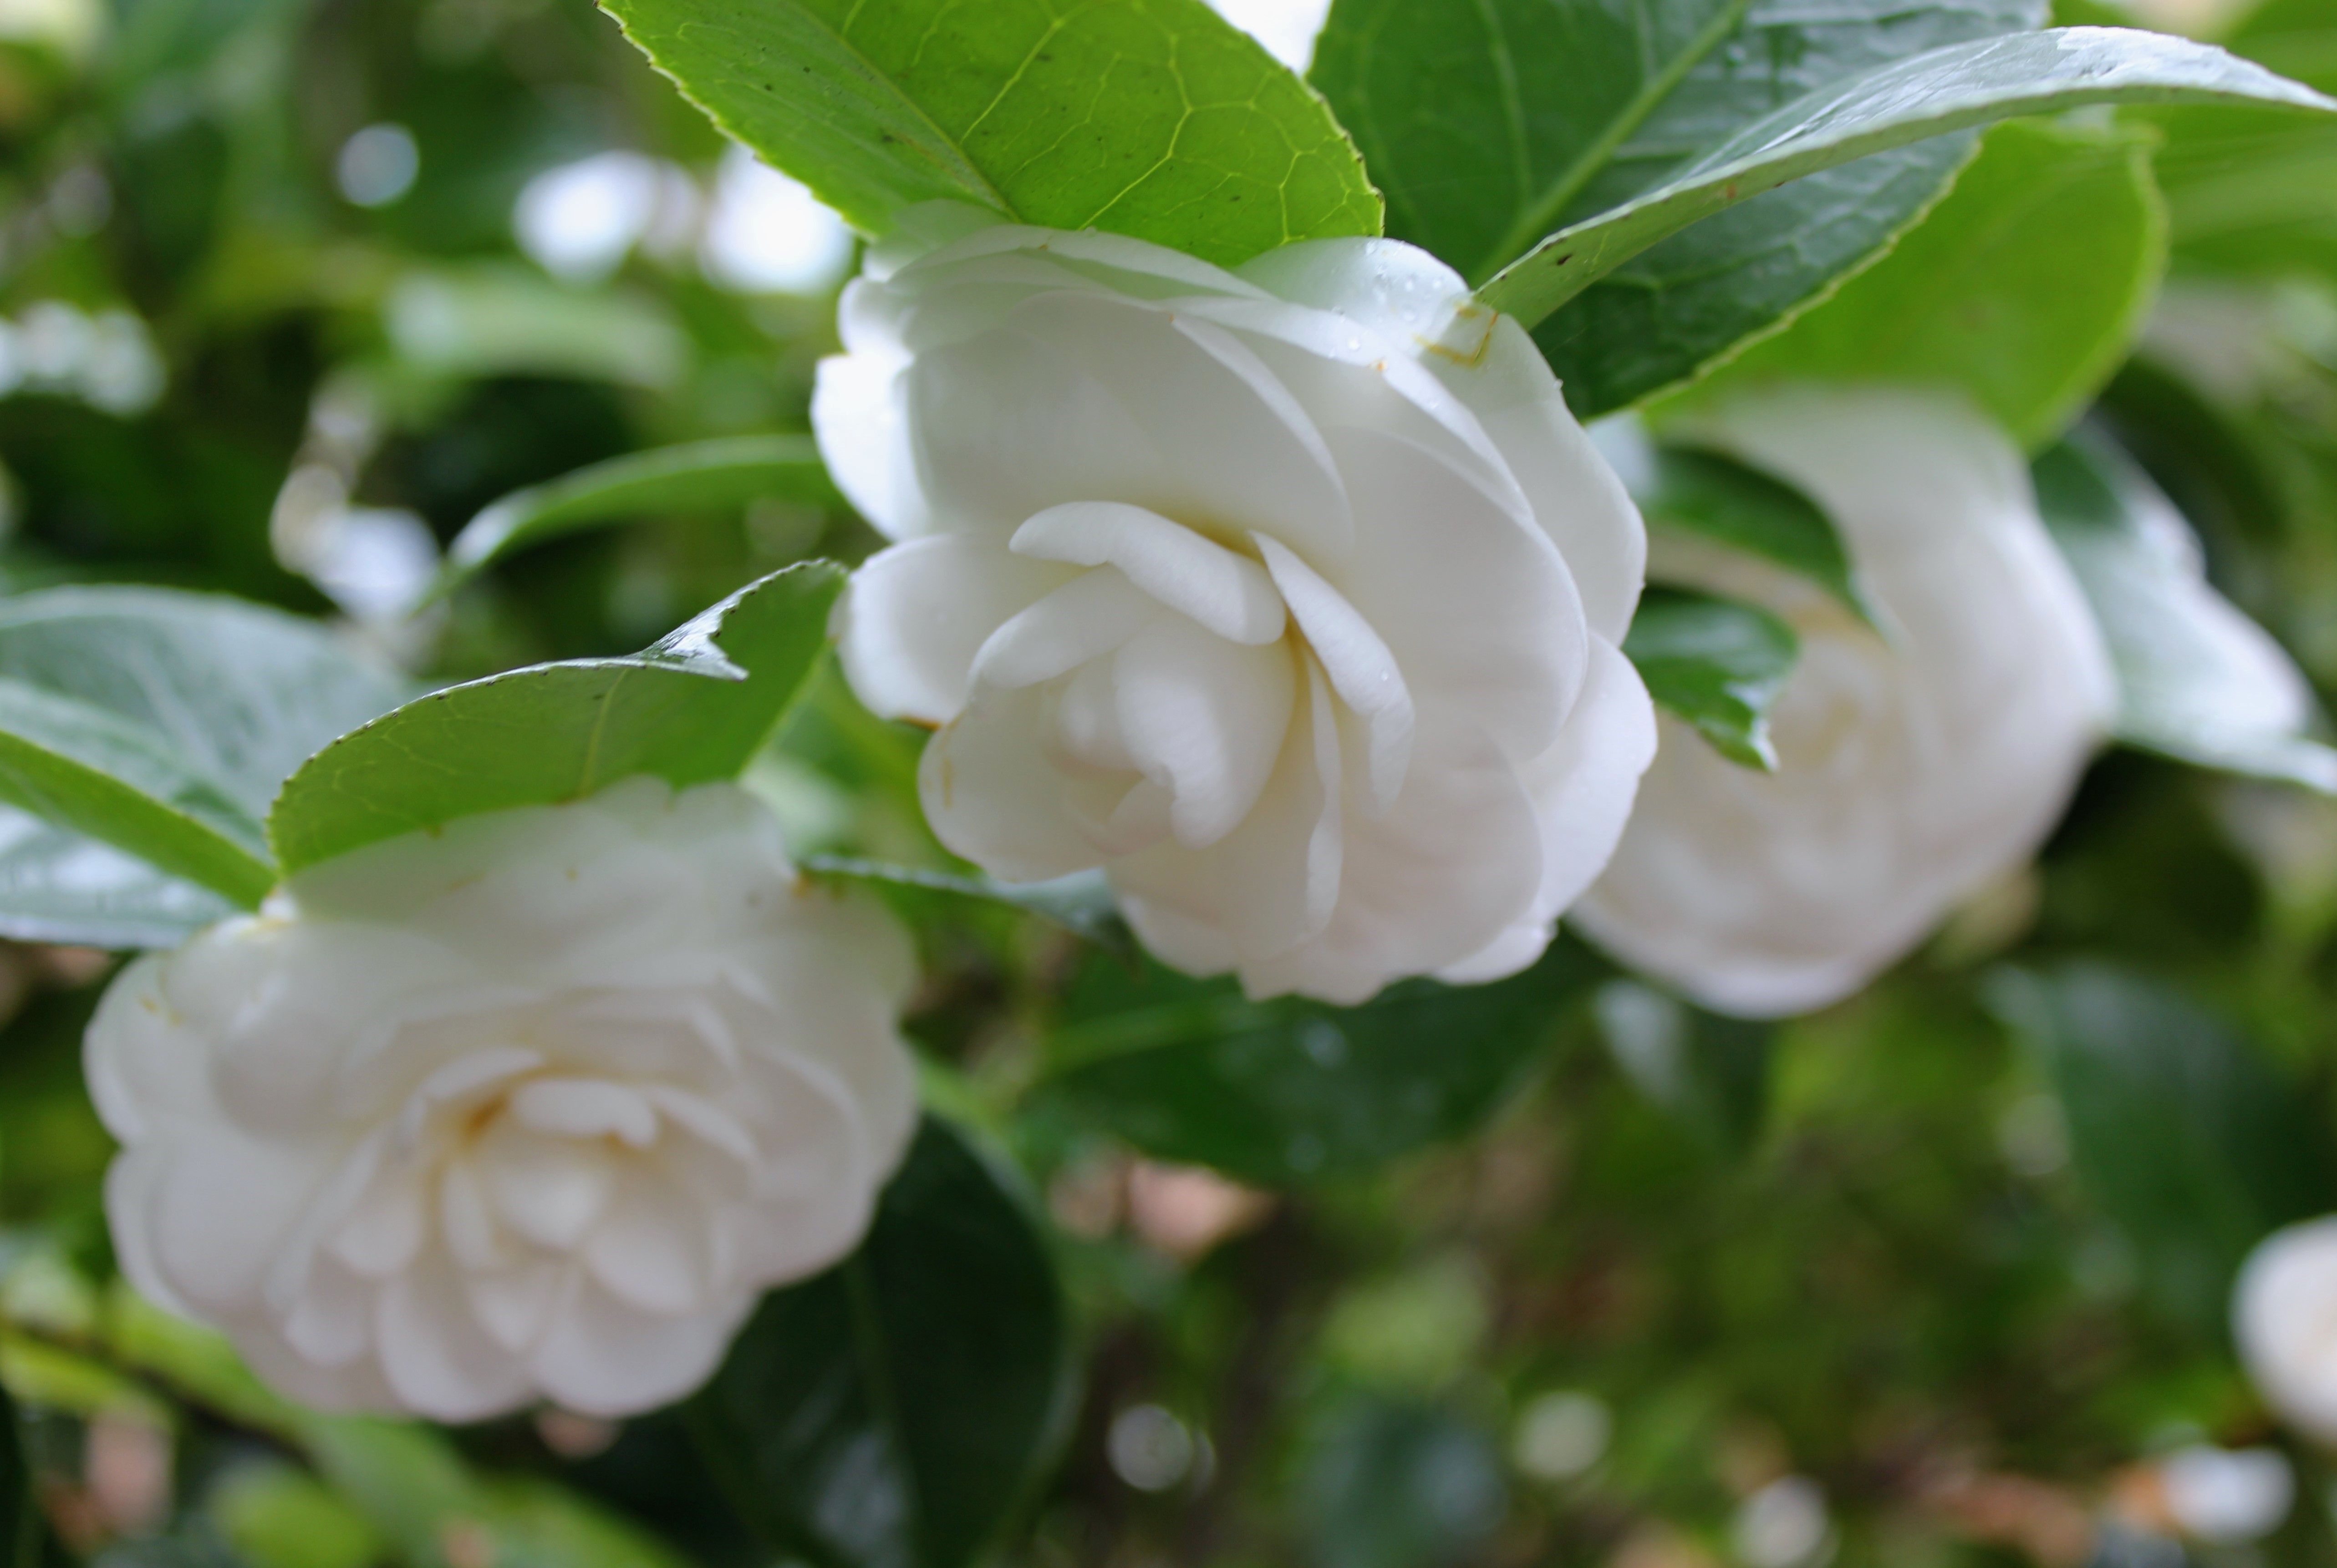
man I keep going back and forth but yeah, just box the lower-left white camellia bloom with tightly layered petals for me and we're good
[89,778,916,1421]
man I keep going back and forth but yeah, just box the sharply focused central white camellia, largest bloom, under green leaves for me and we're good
[813,208,1655,1003]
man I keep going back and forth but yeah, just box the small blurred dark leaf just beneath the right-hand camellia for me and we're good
[1592,979,1776,1157]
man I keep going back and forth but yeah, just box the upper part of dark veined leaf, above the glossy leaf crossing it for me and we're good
[1311,0,2045,283]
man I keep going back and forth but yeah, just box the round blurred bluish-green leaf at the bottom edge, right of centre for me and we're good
[1297,1395,1510,1568]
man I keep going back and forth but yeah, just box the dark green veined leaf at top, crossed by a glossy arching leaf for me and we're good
[1314,0,2042,418]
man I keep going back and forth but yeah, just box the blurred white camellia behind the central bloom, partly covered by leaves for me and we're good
[1575,388,2117,1016]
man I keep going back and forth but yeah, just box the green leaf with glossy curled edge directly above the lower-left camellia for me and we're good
[269,561,844,874]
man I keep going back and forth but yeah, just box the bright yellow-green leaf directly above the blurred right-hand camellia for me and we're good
[1694,122,2166,444]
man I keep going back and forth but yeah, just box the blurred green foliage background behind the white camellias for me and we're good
[14,0,2337,1568]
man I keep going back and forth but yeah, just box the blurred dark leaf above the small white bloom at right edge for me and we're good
[1989,965,2337,1330]
